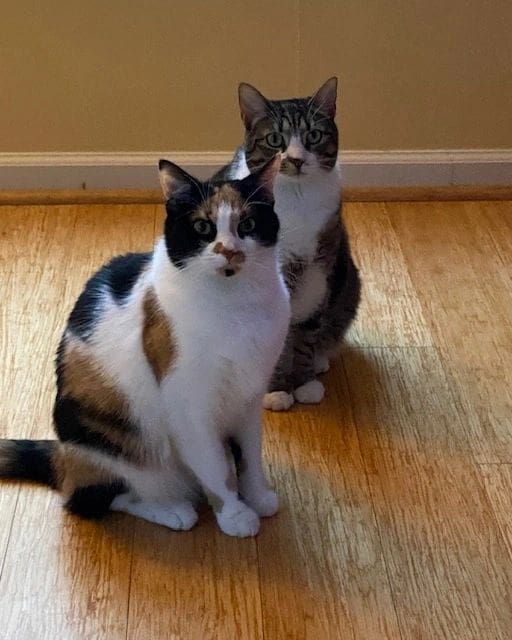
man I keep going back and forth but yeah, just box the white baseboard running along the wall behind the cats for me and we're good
[0,149,512,190]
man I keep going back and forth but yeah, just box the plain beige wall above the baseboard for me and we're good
[0,0,512,152]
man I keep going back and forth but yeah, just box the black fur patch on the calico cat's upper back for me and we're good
[69,253,151,340]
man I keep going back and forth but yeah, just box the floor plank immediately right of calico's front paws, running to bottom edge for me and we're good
[257,364,400,640]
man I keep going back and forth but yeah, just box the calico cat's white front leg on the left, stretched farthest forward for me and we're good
[177,423,260,538]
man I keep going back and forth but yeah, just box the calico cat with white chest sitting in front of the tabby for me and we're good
[0,160,290,537]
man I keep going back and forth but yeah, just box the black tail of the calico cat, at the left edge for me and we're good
[0,440,58,488]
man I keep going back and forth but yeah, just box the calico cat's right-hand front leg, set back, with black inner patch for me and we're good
[231,401,279,517]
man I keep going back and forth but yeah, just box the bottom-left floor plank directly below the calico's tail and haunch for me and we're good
[0,486,131,640]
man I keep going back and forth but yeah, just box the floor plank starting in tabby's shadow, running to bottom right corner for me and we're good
[344,349,512,640]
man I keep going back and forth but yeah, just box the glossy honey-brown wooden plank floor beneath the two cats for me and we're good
[0,202,512,640]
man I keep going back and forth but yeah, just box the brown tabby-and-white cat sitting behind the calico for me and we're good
[217,78,361,411]
